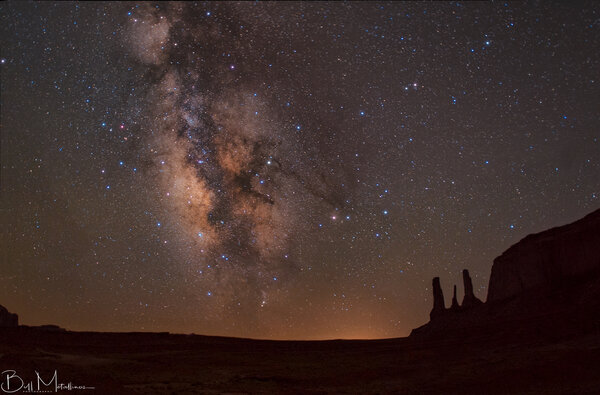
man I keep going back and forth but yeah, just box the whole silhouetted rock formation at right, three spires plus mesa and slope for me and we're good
[411,210,600,337]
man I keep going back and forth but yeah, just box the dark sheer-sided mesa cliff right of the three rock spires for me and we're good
[487,210,600,302]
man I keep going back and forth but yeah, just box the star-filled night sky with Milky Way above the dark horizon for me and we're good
[0,2,600,339]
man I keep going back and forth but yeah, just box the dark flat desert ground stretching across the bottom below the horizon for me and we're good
[0,323,600,394]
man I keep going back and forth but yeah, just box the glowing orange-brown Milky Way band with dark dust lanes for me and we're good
[125,5,343,315]
